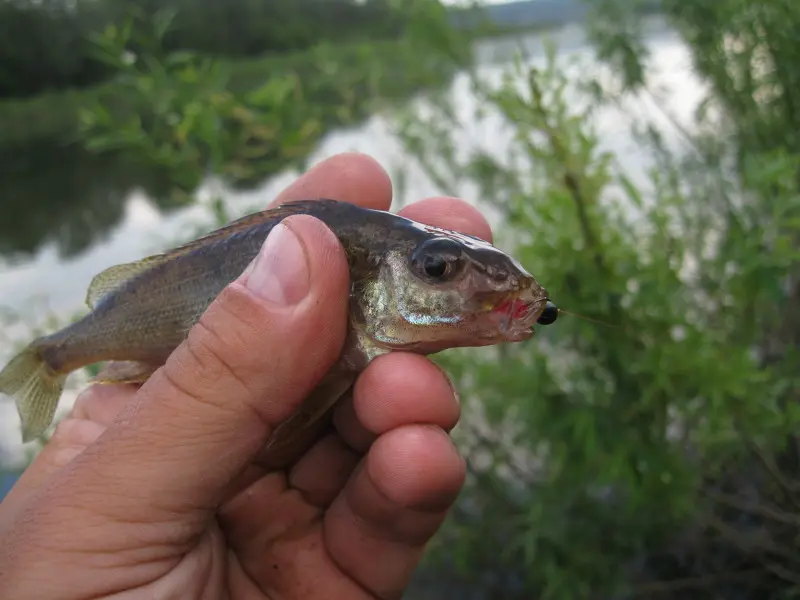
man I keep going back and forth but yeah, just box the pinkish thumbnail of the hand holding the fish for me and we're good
[245,223,310,306]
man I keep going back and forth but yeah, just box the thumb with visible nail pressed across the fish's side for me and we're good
[50,216,349,522]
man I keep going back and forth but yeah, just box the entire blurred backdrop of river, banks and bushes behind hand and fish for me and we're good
[0,0,800,600]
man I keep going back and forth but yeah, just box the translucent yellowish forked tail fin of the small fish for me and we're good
[0,343,66,443]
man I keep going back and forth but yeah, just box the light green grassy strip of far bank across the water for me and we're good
[0,39,468,153]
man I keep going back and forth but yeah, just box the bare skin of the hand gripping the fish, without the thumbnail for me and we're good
[0,154,491,600]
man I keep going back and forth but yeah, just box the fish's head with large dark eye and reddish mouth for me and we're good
[358,224,555,354]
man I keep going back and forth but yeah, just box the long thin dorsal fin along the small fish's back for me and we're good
[86,200,330,309]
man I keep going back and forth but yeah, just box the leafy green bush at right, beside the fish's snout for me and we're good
[401,0,800,600]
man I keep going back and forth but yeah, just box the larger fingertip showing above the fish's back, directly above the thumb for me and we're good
[269,152,392,210]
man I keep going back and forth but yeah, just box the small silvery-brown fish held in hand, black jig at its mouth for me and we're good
[0,199,558,465]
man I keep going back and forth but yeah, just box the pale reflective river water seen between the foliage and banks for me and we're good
[0,18,704,462]
